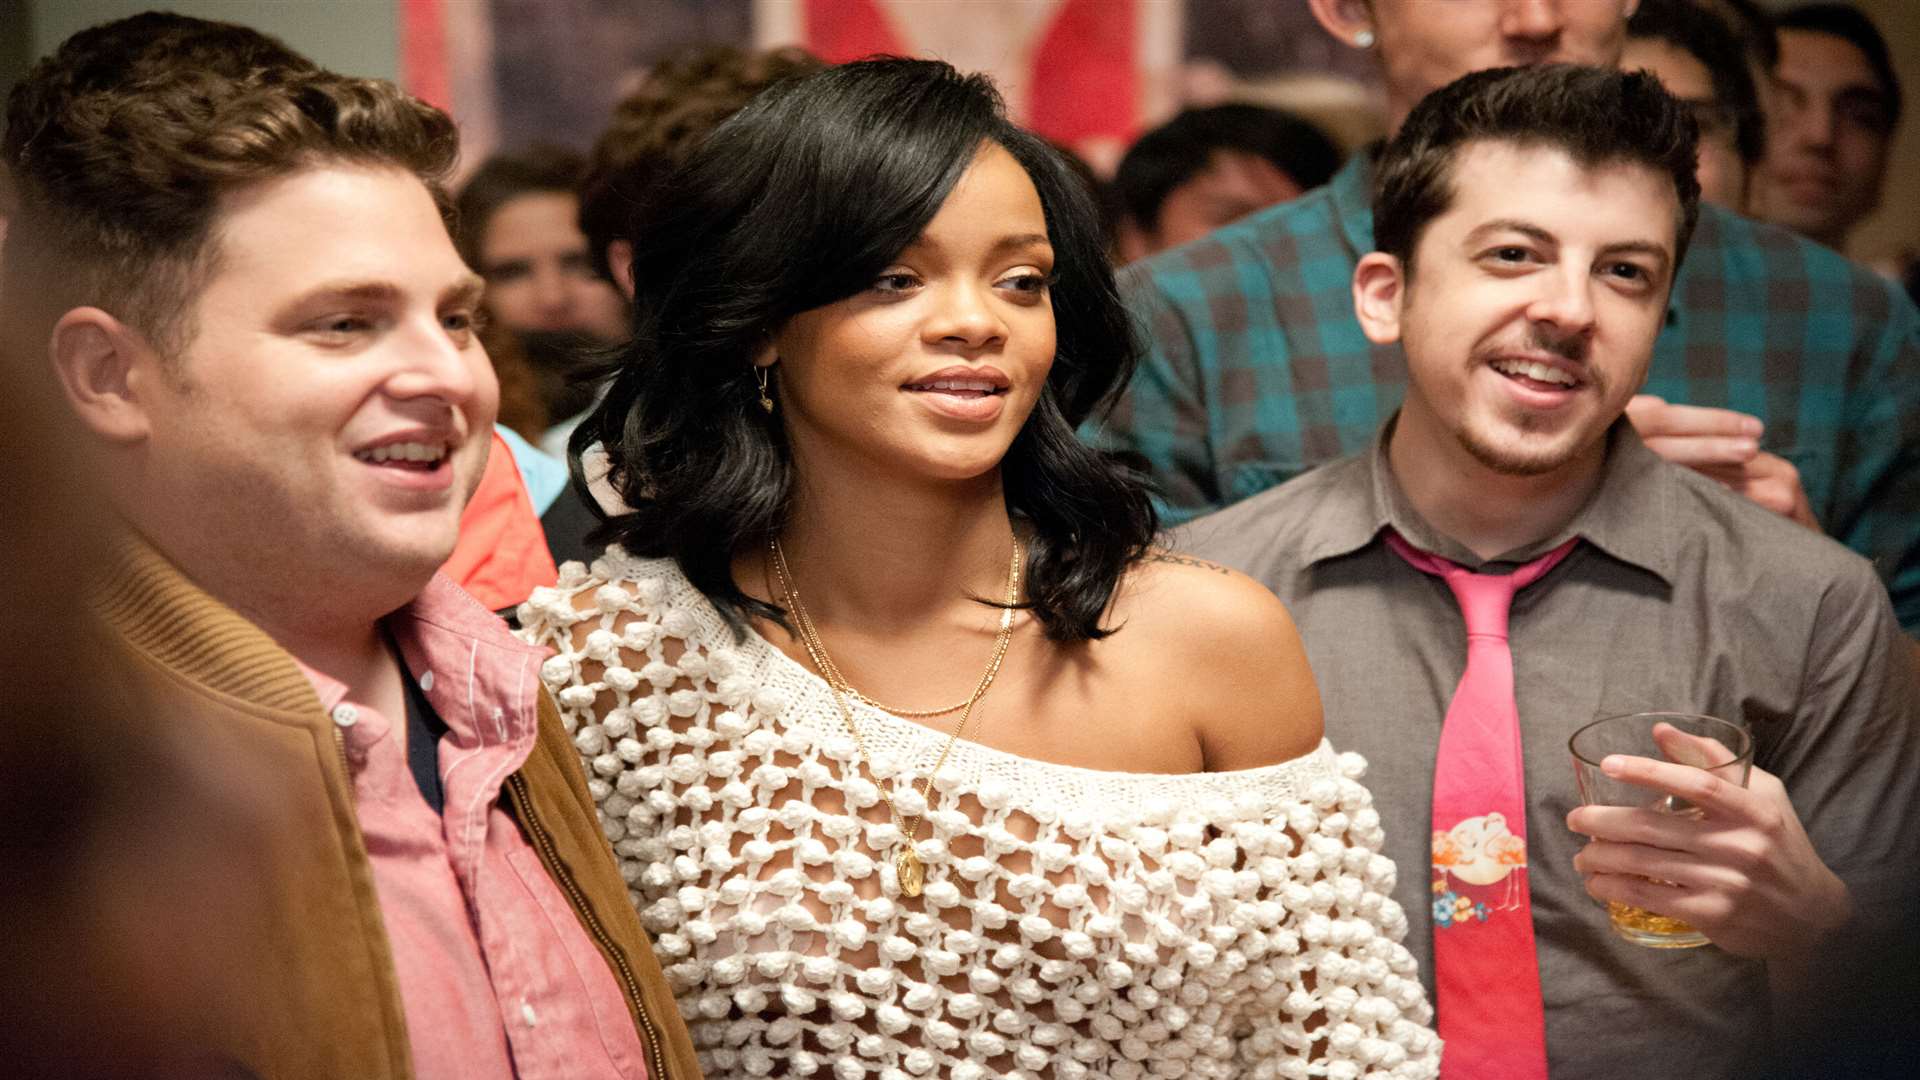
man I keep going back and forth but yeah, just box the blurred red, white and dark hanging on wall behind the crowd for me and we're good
[399,0,1373,173]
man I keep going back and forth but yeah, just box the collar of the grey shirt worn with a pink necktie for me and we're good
[1306,413,1680,584]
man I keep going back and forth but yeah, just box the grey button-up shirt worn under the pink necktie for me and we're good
[1175,421,1920,1080]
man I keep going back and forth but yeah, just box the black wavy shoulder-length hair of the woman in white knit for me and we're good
[572,58,1156,642]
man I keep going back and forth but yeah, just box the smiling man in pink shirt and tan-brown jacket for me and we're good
[0,13,697,1080]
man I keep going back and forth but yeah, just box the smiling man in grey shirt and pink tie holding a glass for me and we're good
[1179,67,1920,1080]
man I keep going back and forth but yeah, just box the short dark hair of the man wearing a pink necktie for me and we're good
[1373,63,1699,273]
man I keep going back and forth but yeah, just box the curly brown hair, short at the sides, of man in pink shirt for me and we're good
[0,12,459,356]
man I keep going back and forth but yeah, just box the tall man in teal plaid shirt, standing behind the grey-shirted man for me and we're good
[1092,0,1920,634]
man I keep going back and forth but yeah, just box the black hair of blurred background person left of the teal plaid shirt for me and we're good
[1114,104,1340,231]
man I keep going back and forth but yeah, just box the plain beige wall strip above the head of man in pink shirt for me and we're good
[23,0,399,79]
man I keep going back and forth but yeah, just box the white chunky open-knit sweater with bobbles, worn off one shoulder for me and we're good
[520,548,1440,1080]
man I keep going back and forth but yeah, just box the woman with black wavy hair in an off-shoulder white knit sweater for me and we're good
[520,60,1438,1080]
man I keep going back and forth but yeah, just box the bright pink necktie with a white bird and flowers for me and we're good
[1386,532,1578,1080]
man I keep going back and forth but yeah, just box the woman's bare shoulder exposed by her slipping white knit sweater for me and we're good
[1114,548,1321,771]
